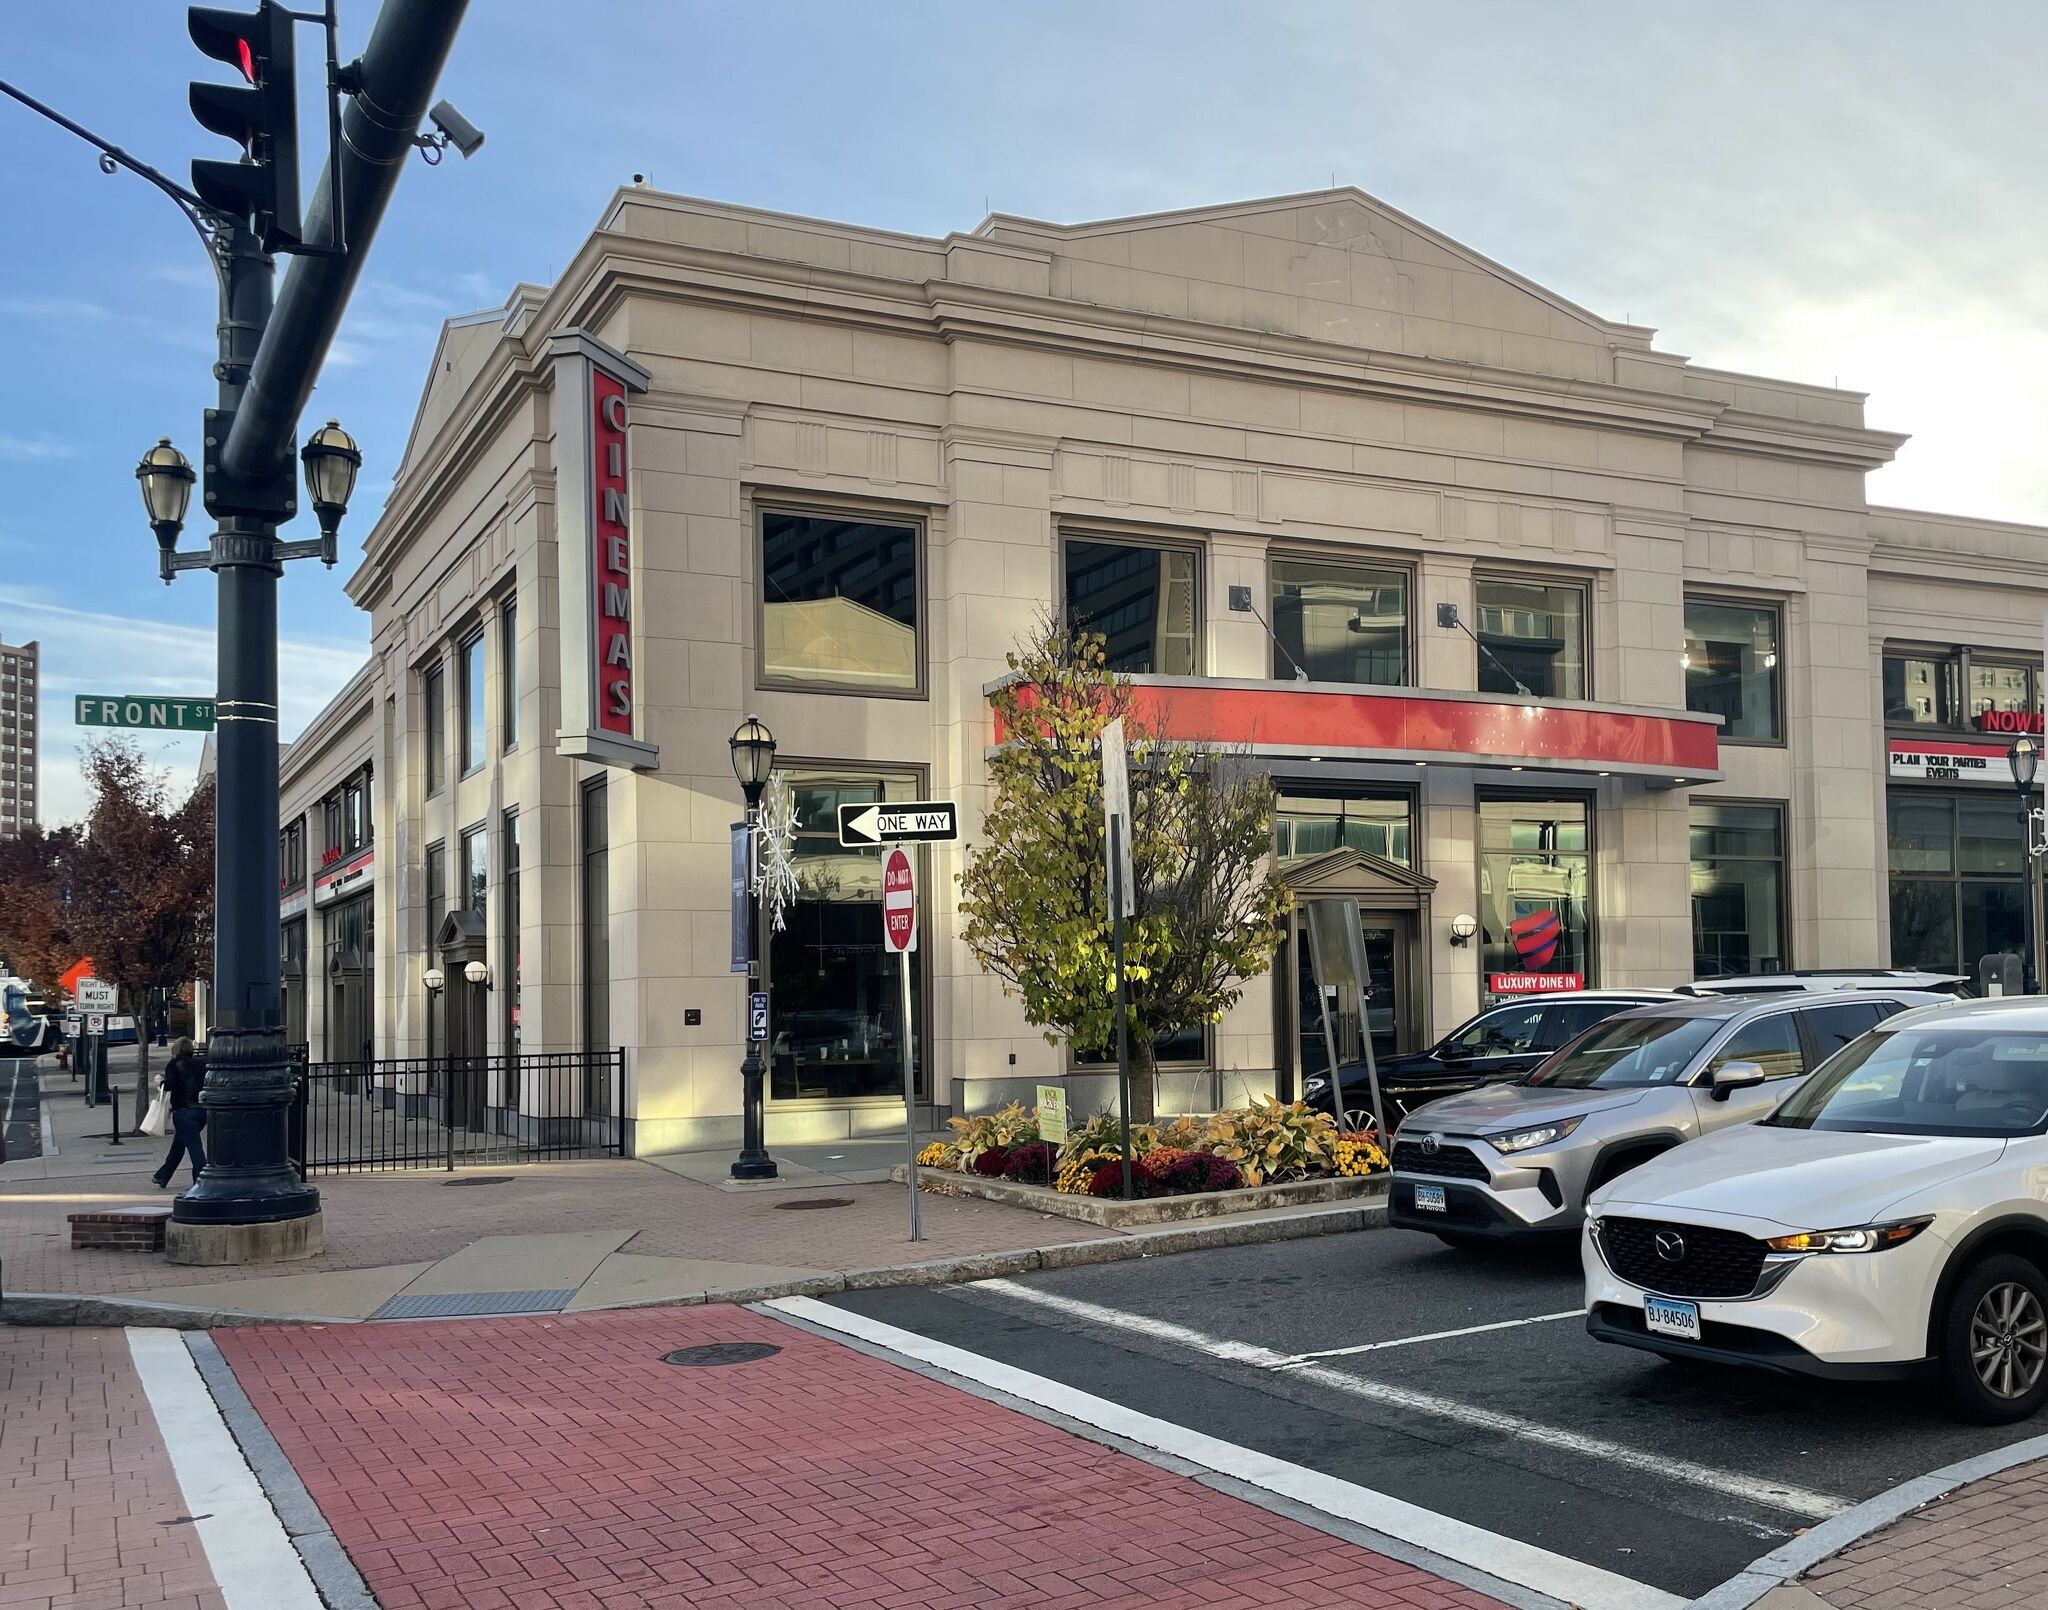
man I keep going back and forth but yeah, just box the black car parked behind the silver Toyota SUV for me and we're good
[1300,989,1675,1129]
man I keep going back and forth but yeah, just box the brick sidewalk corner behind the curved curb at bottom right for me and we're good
[1798,1460,2048,1610]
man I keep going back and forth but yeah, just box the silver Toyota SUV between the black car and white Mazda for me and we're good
[1386,989,1950,1245]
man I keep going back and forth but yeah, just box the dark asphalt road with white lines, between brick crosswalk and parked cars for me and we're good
[831,1229,2048,1598]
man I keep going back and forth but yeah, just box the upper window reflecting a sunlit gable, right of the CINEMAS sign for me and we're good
[760,508,924,692]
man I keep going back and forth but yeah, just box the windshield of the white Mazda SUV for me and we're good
[1763,1028,2048,1137]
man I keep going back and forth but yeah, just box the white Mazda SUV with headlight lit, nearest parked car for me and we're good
[1583,998,2048,1424]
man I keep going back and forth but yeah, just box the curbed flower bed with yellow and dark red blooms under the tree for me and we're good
[918,1096,1386,1200]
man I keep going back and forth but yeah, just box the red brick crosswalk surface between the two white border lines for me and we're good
[219,1309,1497,1610]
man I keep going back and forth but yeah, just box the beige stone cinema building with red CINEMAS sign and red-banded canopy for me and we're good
[281,188,2048,1151]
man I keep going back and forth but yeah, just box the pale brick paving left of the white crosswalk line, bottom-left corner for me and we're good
[0,1327,225,1610]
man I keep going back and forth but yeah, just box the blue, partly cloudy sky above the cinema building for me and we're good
[0,0,2048,819]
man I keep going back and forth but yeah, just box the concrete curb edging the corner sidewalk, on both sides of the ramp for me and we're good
[0,1200,1386,1331]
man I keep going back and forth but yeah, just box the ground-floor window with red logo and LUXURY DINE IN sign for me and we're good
[1479,799,1593,998]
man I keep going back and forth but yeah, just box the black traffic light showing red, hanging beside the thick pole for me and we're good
[186,0,299,252]
